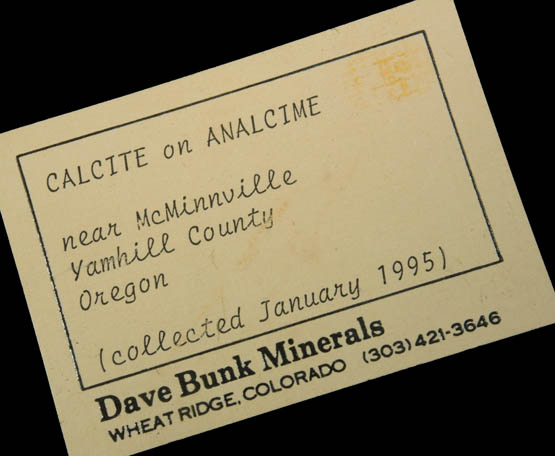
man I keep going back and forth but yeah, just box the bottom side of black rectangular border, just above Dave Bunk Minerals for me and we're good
[83,260,503,390]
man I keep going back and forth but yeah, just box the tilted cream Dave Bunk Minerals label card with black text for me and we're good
[0,0,555,455]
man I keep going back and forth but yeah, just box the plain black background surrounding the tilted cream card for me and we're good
[0,1,555,455]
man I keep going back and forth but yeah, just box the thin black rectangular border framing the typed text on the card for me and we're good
[16,30,503,391]
